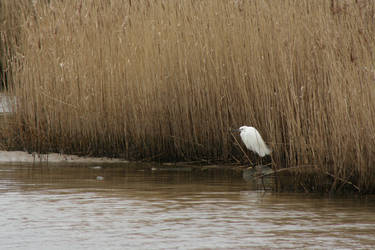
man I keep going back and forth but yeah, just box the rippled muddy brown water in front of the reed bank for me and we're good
[0,164,375,249]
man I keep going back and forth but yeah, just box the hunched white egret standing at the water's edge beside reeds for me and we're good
[239,126,271,157]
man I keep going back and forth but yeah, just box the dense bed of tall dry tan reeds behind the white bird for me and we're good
[1,0,375,192]
